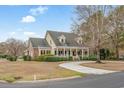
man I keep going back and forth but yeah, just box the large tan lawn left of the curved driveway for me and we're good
[0,61,84,80]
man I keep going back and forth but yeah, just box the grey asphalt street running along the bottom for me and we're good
[0,72,124,88]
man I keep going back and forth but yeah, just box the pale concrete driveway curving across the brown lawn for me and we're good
[59,61,116,74]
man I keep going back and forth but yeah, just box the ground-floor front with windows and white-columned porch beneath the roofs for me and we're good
[38,47,89,57]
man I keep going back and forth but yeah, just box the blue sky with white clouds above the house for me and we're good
[0,5,74,42]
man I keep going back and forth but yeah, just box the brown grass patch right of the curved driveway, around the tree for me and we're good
[81,61,124,71]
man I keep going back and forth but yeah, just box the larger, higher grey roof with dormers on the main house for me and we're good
[47,30,83,47]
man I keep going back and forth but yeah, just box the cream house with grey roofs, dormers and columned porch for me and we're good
[25,31,89,57]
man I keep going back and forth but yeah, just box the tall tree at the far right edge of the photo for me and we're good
[105,6,124,59]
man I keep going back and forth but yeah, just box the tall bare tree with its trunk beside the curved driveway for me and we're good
[71,5,111,63]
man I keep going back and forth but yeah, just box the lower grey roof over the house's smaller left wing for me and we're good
[29,38,50,47]
